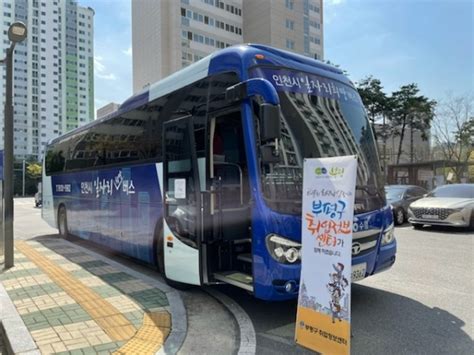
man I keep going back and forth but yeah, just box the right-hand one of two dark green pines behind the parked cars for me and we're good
[389,83,436,164]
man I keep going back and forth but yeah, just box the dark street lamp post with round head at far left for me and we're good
[0,22,27,269]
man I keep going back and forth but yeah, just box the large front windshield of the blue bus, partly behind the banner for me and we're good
[251,67,385,214]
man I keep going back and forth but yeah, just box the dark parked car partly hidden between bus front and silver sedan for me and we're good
[385,185,428,225]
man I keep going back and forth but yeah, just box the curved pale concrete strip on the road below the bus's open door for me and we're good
[203,287,257,355]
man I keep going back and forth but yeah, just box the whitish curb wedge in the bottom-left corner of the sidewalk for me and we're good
[0,282,41,355]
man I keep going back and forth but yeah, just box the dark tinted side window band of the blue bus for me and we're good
[46,79,211,175]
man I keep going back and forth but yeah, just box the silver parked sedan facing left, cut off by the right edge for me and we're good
[408,184,474,230]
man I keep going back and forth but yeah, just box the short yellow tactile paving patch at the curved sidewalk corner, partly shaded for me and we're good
[113,311,171,355]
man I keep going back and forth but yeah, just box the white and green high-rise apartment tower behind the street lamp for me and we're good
[0,0,94,159]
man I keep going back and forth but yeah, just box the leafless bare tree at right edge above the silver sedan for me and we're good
[432,94,474,181]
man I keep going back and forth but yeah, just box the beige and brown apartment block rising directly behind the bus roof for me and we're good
[132,0,323,92]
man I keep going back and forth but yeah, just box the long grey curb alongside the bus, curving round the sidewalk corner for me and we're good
[60,239,188,355]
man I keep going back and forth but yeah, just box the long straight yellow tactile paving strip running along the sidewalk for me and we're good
[16,241,136,341]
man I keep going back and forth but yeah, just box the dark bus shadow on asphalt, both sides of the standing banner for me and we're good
[219,284,473,354]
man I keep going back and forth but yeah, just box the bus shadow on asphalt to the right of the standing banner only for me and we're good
[352,284,473,354]
